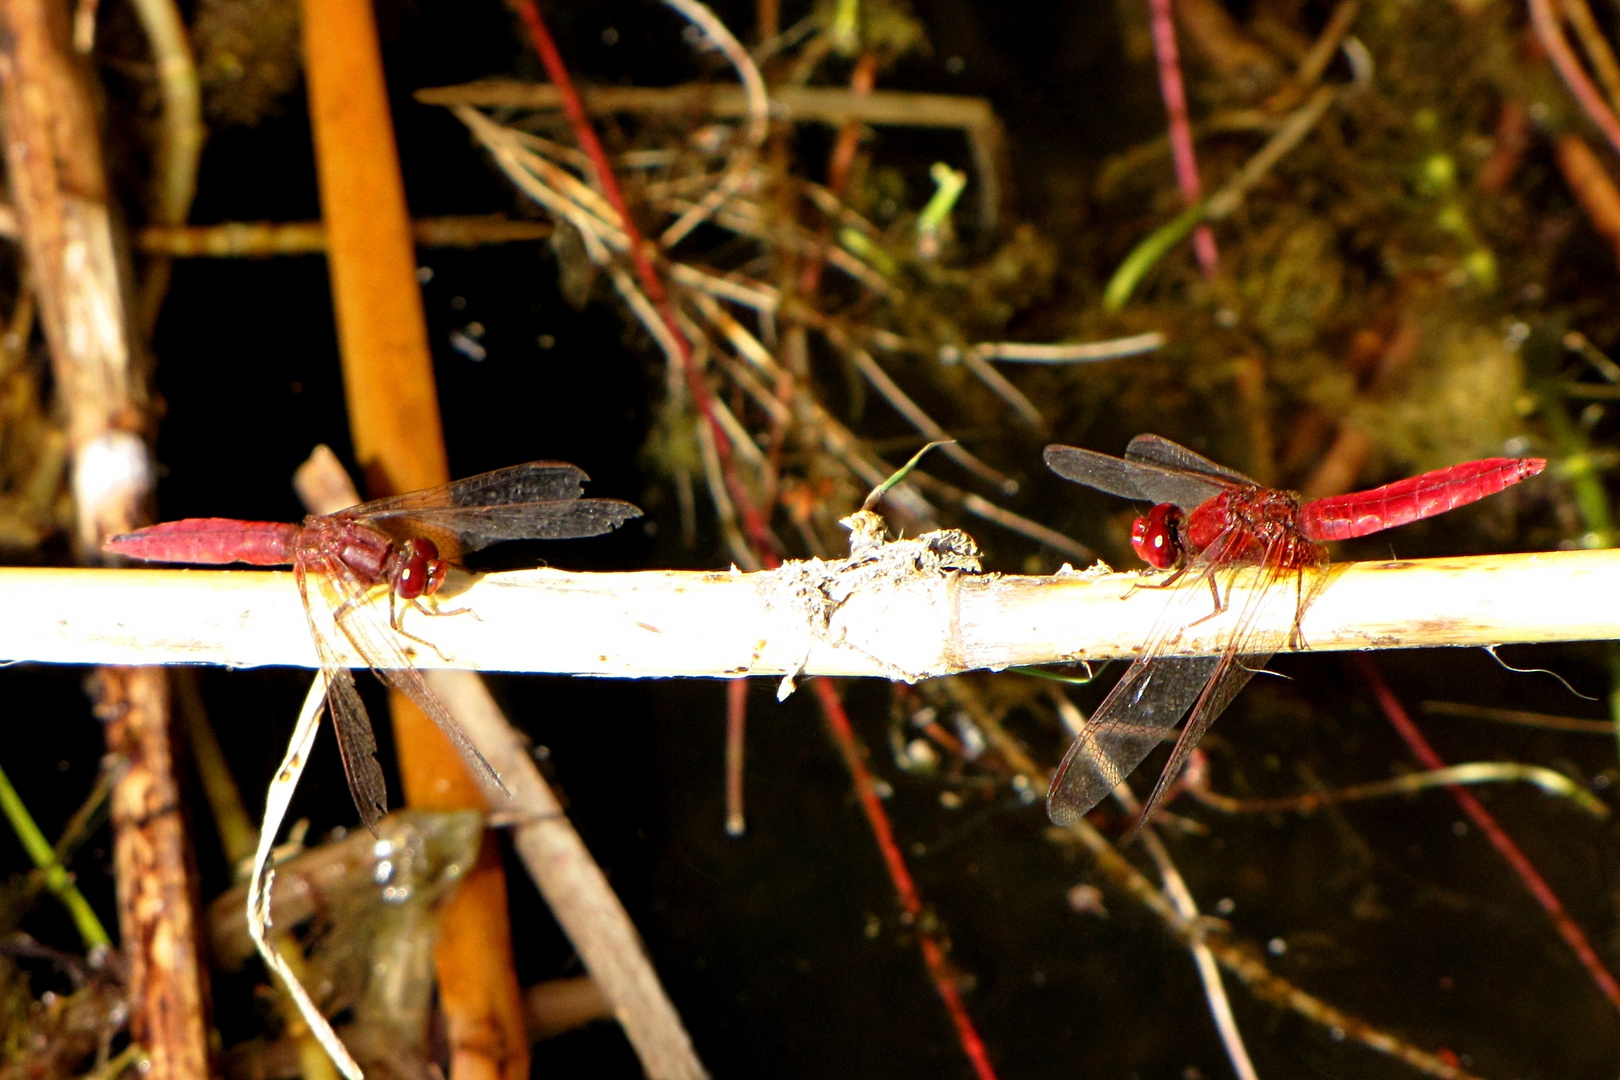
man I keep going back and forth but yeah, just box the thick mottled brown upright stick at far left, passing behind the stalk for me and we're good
[0,0,209,1080]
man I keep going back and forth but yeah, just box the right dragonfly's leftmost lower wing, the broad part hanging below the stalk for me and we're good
[1047,654,1220,826]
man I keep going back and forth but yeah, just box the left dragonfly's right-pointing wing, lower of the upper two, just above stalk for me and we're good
[365,499,642,555]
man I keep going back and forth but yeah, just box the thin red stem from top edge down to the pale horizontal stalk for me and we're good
[514,0,774,552]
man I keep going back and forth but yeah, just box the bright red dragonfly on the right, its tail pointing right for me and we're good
[1045,436,1547,824]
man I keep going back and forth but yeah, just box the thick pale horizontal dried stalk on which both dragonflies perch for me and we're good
[0,541,1620,678]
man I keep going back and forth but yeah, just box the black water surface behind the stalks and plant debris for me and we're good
[0,0,1620,1078]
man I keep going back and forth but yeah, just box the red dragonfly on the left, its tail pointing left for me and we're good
[102,461,642,832]
